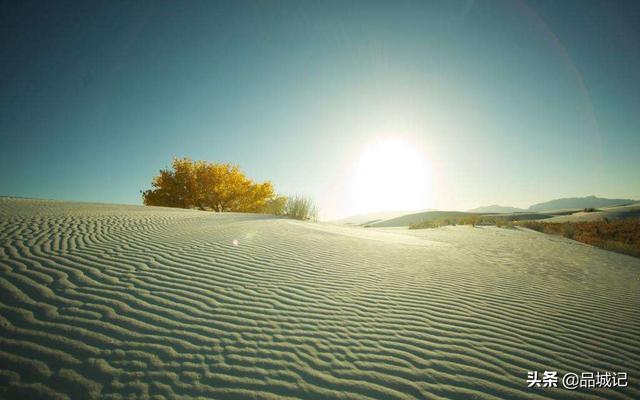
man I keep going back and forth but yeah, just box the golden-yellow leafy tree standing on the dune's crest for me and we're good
[142,158,276,213]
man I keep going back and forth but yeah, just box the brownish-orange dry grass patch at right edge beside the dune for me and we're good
[519,218,640,257]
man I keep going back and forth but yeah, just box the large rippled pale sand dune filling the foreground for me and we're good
[0,199,640,399]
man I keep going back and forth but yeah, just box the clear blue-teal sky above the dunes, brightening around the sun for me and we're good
[0,0,640,218]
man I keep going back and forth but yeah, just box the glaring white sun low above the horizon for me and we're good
[352,139,431,213]
